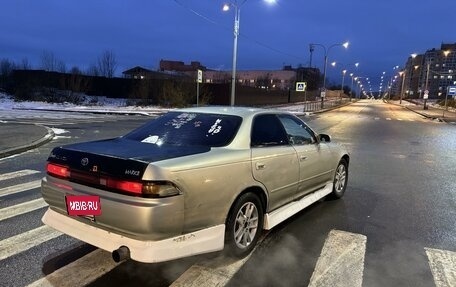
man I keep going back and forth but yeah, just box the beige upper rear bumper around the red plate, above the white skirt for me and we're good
[41,176,184,241]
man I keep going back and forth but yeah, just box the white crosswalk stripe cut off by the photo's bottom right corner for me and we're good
[424,248,456,287]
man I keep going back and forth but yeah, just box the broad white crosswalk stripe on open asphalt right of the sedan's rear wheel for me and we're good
[309,230,367,287]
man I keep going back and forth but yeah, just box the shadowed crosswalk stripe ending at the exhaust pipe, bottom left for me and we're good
[27,249,120,287]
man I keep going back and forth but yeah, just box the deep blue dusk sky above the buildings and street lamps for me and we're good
[0,0,456,88]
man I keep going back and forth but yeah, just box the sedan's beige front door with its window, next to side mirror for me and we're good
[279,114,334,198]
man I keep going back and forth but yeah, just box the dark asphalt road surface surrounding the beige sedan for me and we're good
[0,101,456,286]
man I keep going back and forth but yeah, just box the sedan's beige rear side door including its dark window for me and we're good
[251,114,299,211]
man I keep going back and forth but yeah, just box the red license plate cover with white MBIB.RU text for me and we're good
[65,195,101,216]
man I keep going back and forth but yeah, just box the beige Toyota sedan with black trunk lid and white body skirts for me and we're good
[42,107,350,262]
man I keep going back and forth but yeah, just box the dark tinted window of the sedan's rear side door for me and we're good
[251,114,288,147]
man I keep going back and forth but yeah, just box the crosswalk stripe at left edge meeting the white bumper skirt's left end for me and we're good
[0,225,62,260]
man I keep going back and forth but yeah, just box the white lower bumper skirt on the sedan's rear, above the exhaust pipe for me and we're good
[42,208,225,263]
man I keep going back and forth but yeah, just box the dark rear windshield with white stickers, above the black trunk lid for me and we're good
[124,112,242,147]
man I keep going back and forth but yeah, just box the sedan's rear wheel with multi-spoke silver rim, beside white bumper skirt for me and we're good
[225,193,264,257]
